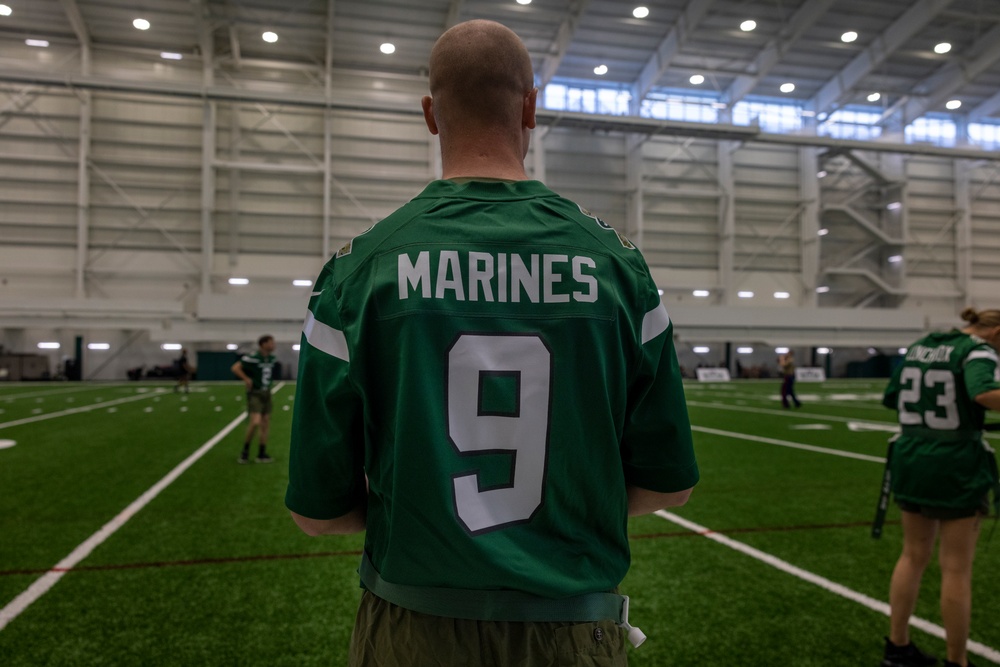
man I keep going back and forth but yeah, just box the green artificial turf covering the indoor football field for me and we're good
[0,380,1000,667]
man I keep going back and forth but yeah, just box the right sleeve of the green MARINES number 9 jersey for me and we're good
[621,300,699,493]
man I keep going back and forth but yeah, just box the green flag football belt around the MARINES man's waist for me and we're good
[358,553,628,625]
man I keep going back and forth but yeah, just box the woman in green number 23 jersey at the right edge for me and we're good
[882,308,1000,667]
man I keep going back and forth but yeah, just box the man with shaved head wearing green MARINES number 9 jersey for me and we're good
[285,21,698,667]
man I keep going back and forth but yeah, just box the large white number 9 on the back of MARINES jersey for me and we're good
[448,334,551,534]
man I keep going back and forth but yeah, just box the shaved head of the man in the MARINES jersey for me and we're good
[430,20,534,129]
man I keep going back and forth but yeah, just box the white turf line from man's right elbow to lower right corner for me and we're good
[655,510,1000,664]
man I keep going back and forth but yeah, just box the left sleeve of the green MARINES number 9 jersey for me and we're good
[285,270,366,519]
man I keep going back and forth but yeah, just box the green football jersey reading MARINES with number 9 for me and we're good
[286,181,698,598]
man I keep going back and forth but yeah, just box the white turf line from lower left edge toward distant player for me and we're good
[0,383,284,630]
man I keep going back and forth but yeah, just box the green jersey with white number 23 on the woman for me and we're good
[882,330,1000,509]
